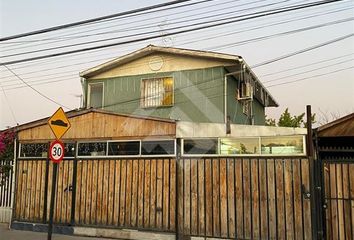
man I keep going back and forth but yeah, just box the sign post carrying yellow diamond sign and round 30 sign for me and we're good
[47,108,71,240]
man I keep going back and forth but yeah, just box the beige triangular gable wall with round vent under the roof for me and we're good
[89,53,235,79]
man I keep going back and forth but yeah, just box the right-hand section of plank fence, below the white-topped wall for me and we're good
[177,158,311,239]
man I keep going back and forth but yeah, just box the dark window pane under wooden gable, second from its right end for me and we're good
[108,141,140,156]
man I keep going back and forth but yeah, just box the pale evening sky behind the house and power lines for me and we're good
[0,0,354,129]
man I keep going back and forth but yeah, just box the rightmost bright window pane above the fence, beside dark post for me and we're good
[261,136,305,154]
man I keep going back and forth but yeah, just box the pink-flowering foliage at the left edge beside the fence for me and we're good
[0,130,15,186]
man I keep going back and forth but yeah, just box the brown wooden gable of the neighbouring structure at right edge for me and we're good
[317,113,354,137]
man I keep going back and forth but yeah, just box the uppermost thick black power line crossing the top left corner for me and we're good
[0,0,199,42]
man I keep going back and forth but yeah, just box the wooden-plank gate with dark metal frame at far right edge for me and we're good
[322,160,354,240]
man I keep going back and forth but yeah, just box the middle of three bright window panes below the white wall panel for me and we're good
[220,138,260,155]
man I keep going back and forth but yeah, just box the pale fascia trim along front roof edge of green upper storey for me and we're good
[80,45,242,78]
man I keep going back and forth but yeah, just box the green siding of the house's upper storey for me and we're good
[85,67,264,125]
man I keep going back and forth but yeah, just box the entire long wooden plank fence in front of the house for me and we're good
[14,158,311,239]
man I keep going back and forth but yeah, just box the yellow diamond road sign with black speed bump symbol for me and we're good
[48,107,71,140]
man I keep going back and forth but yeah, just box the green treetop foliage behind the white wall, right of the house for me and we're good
[266,108,316,127]
